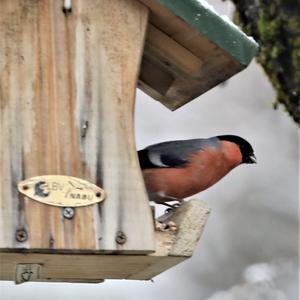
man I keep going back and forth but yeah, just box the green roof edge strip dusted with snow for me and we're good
[157,0,258,65]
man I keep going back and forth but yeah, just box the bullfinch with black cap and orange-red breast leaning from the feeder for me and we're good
[138,135,257,207]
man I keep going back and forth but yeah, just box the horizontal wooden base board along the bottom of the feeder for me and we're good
[0,253,185,282]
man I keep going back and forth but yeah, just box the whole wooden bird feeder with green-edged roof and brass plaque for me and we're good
[0,0,257,283]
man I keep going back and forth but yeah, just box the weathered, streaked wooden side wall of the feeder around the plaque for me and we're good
[0,0,154,253]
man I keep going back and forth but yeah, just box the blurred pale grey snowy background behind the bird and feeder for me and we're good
[0,0,299,300]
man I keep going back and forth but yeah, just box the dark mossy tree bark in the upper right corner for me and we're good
[225,0,300,124]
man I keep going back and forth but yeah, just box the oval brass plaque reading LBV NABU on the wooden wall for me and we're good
[18,175,105,207]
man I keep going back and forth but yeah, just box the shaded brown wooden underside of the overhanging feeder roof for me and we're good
[139,0,246,110]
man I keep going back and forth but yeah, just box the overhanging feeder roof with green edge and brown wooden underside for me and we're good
[139,0,257,110]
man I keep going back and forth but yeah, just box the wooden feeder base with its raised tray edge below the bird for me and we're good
[0,200,210,282]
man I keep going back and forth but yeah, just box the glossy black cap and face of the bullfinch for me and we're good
[217,135,256,164]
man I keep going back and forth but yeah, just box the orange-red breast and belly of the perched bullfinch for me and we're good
[143,141,242,199]
